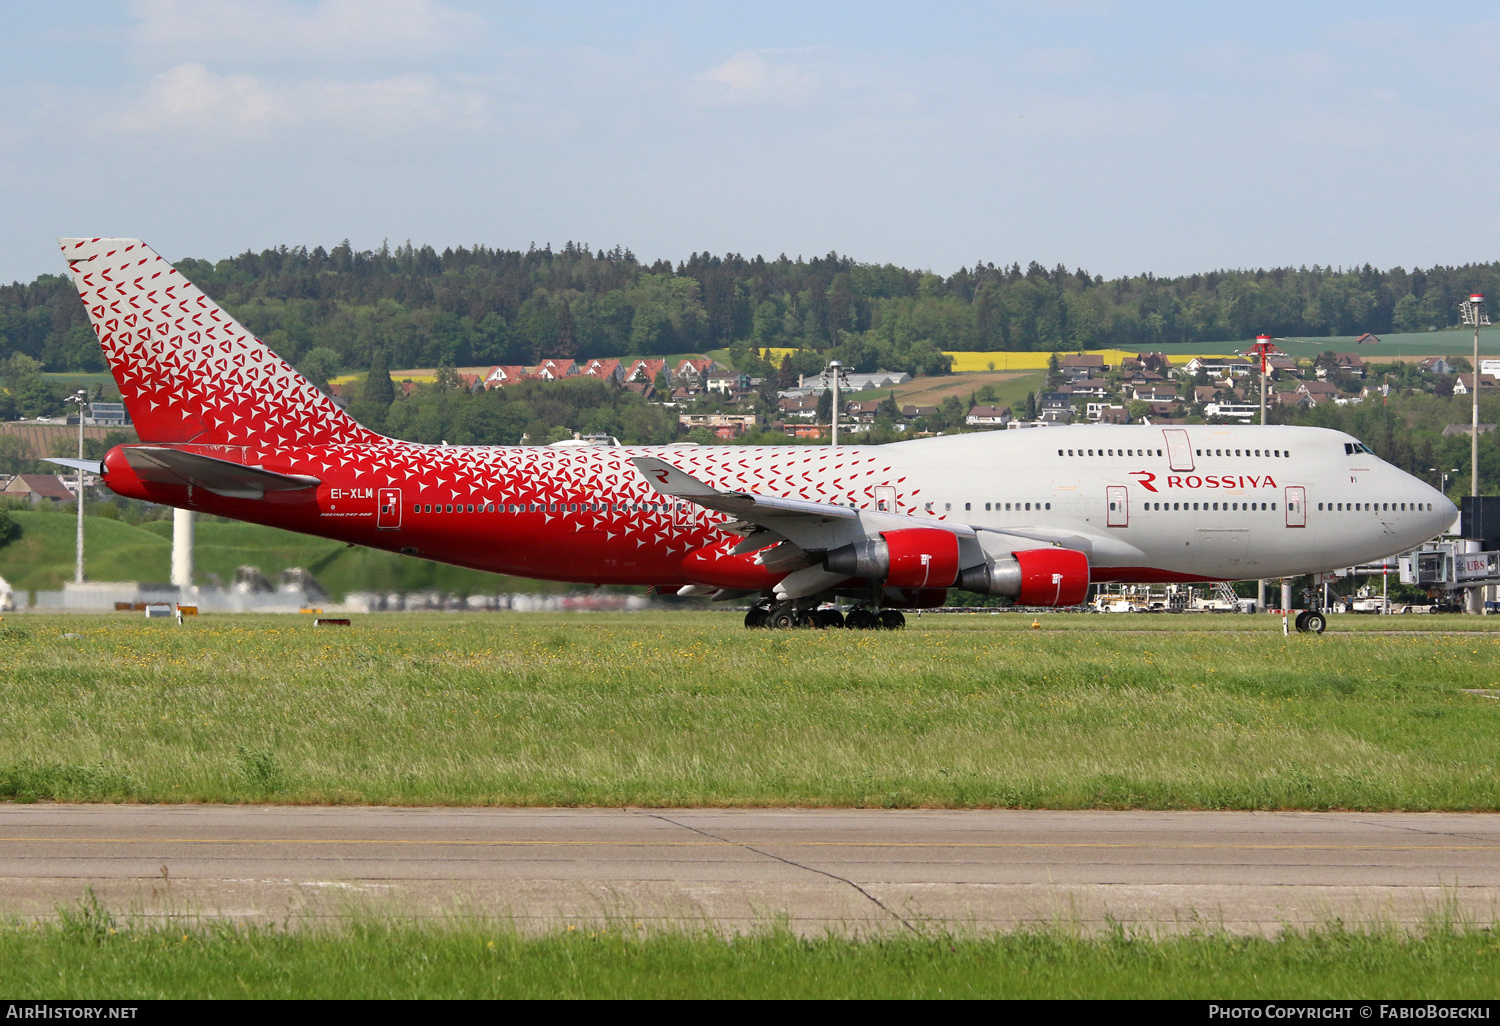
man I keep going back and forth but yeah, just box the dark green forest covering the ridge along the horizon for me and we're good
[0,242,1500,378]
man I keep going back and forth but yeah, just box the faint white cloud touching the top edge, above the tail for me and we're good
[134,0,479,60]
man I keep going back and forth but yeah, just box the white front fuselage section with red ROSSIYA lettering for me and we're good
[744,425,1457,581]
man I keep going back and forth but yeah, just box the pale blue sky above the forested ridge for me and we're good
[0,0,1500,281]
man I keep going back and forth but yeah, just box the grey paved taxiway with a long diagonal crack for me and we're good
[0,804,1500,933]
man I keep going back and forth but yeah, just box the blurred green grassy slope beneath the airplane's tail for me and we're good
[0,510,566,599]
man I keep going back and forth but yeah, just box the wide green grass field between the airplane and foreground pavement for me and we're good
[0,614,1500,810]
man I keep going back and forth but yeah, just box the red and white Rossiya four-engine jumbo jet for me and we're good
[49,239,1454,629]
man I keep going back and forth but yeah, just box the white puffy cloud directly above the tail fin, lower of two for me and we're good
[111,63,483,134]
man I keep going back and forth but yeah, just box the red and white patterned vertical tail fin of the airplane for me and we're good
[59,239,386,446]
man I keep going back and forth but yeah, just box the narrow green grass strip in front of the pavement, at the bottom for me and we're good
[0,905,1500,1001]
